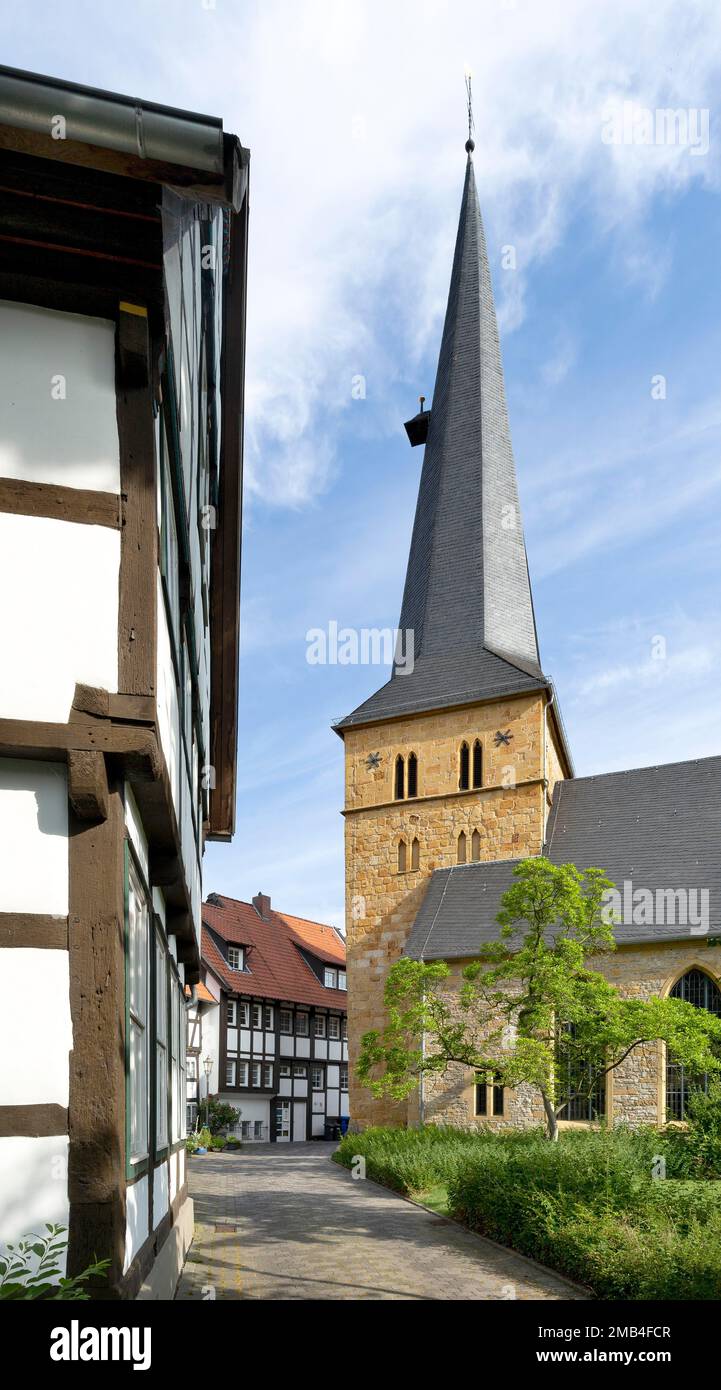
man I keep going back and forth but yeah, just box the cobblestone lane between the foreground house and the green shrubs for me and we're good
[176,1143,586,1301]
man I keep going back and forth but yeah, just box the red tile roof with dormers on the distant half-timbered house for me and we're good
[201,894,347,1013]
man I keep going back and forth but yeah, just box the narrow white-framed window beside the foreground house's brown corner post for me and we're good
[128,859,150,1162]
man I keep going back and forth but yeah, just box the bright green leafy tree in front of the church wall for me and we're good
[357,858,721,1140]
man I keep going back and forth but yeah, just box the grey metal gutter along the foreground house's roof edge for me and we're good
[0,68,225,178]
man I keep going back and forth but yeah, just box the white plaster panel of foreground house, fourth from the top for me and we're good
[0,947,72,1106]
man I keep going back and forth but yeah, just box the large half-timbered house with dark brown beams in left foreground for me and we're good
[0,68,249,1298]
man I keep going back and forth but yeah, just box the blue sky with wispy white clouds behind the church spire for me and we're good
[0,0,721,924]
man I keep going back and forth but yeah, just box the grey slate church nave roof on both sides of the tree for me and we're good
[406,758,721,960]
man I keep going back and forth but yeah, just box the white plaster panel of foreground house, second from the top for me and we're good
[0,513,121,723]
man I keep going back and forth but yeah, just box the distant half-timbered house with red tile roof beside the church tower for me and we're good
[189,892,349,1143]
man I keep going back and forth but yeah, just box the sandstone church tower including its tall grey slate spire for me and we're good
[335,139,572,1127]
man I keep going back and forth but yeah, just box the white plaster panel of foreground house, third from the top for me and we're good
[0,761,68,911]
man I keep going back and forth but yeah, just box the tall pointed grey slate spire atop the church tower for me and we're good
[338,150,547,728]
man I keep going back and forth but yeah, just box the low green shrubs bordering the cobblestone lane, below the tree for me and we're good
[336,1126,721,1300]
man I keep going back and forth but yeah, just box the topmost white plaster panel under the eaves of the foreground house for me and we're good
[0,300,121,492]
